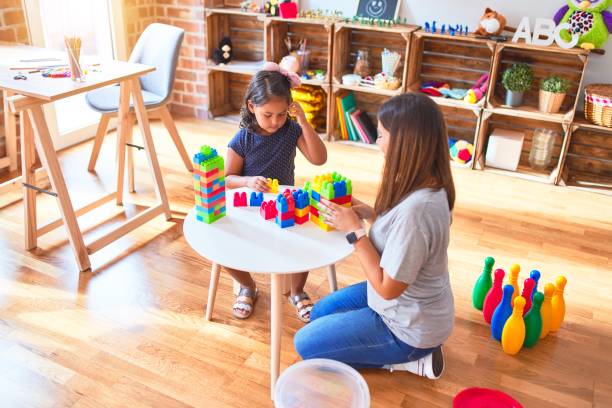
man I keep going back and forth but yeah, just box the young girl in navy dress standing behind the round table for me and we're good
[225,62,327,322]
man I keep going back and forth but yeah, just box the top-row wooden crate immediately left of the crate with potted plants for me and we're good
[406,31,496,109]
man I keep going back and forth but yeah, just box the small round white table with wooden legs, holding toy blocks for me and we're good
[183,186,353,396]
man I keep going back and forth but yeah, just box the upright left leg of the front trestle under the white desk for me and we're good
[19,111,37,251]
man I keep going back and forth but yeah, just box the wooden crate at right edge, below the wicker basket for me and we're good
[558,113,612,195]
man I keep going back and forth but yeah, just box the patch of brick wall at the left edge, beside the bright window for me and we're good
[0,0,29,164]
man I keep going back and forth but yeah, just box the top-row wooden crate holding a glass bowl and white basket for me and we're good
[332,22,418,96]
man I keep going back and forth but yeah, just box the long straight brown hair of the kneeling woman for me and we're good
[374,93,455,214]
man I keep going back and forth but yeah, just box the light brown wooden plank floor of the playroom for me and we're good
[0,116,612,408]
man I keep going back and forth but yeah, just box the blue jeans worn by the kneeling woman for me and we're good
[293,282,434,368]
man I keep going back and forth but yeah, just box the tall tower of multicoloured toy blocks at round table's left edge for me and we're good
[193,146,225,224]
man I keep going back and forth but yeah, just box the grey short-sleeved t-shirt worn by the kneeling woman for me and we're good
[368,189,455,348]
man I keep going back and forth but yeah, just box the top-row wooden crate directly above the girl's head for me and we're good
[265,17,334,82]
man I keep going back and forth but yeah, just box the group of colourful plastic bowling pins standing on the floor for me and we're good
[472,257,567,355]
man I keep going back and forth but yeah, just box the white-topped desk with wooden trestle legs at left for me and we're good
[0,46,171,271]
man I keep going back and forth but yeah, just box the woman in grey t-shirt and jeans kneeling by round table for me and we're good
[294,94,455,378]
